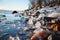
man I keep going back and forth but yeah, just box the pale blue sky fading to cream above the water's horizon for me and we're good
[0,0,29,10]
